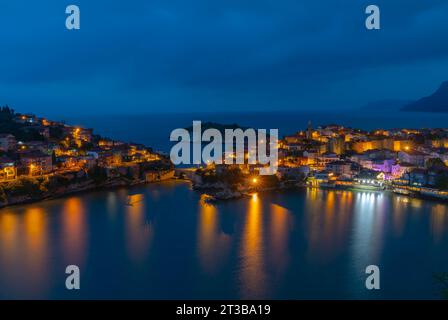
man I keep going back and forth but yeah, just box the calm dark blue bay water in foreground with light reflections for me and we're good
[0,181,448,299]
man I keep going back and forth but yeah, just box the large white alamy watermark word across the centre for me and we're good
[170,121,278,175]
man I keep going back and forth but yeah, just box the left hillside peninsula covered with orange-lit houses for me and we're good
[0,106,174,207]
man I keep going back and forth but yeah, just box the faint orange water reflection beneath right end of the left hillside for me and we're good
[125,194,153,261]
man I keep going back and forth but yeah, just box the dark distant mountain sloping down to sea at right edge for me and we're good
[401,81,448,112]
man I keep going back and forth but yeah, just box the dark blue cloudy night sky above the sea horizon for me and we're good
[0,0,448,115]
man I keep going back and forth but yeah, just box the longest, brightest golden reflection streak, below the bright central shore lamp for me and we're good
[240,193,266,299]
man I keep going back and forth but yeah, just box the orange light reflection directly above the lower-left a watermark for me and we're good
[62,197,87,266]
